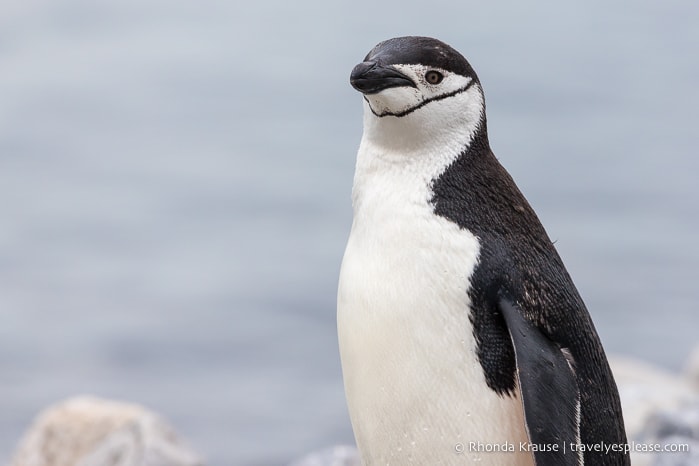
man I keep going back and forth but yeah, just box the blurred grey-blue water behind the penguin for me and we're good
[0,0,699,466]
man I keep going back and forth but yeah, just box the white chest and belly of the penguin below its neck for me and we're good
[338,154,532,466]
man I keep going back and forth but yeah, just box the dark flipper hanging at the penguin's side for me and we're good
[499,297,582,466]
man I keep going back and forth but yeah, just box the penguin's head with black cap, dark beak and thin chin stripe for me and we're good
[350,36,485,129]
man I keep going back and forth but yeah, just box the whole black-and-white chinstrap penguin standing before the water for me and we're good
[337,37,629,466]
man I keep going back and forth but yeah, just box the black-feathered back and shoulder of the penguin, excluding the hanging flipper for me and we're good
[432,122,630,465]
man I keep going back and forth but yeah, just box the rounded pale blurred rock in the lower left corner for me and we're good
[10,396,204,466]
